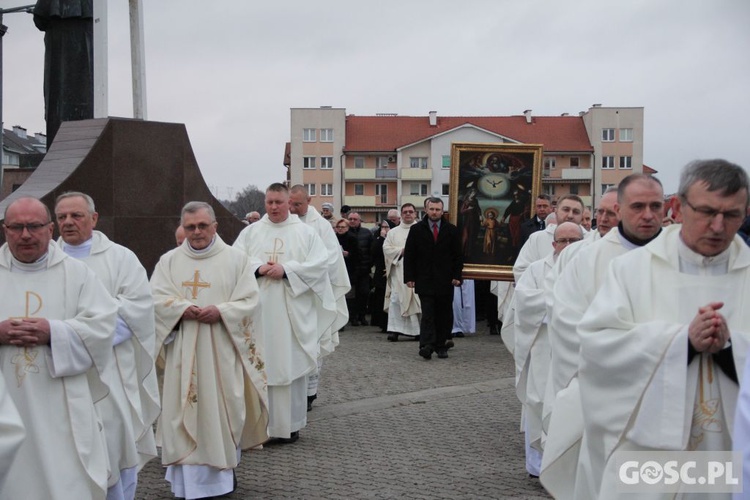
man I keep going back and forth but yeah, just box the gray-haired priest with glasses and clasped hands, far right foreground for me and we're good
[575,160,750,499]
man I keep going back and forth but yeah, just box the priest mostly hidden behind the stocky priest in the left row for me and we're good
[289,184,351,411]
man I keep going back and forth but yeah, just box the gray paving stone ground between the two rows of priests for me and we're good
[136,324,550,500]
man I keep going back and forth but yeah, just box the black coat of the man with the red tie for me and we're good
[404,217,464,296]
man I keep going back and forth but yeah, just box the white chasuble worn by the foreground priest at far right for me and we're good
[576,225,750,497]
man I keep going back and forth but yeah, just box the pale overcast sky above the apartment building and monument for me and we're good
[0,0,750,198]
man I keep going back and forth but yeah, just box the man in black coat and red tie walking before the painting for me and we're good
[404,197,463,359]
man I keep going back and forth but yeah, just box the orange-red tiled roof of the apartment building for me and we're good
[344,115,593,153]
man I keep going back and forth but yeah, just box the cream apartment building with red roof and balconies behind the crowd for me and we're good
[285,104,647,224]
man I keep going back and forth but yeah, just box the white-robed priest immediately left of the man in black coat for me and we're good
[383,203,422,342]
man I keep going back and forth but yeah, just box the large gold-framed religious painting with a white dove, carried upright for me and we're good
[449,143,542,281]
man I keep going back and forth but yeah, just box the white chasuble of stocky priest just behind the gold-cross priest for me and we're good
[234,214,337,386]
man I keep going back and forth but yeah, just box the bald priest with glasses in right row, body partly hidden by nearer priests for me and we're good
[513,222,584,477]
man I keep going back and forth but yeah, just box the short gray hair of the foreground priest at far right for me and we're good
[677,158,750,200]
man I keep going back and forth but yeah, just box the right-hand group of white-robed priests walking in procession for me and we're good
[503,160,750,499]
